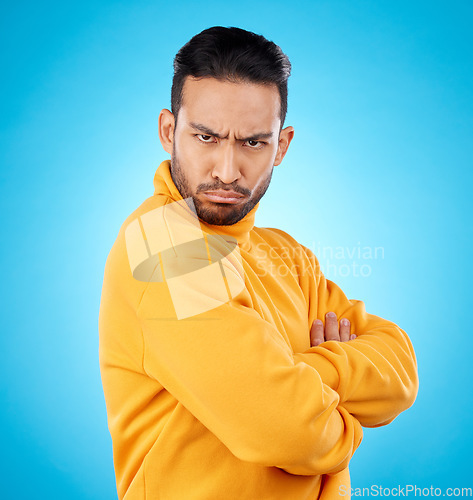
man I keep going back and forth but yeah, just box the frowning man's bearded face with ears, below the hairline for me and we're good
[160,77,293,225]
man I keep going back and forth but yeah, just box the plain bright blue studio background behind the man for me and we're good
[0,0,473,499]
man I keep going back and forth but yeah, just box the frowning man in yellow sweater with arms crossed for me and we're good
[100,27,417,500]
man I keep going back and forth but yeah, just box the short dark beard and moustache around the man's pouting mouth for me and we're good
[171,146,273,226]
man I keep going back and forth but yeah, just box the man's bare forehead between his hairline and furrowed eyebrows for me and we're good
[178,77,280,130]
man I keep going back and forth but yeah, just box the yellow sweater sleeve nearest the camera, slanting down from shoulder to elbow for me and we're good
[138,284,362,475]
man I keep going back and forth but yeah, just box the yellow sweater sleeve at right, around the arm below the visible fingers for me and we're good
[295,245,418,427]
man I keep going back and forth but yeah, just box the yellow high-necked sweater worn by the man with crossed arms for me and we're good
[99,161,418,500]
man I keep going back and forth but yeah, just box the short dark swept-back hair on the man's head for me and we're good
[171,26,291,128]
